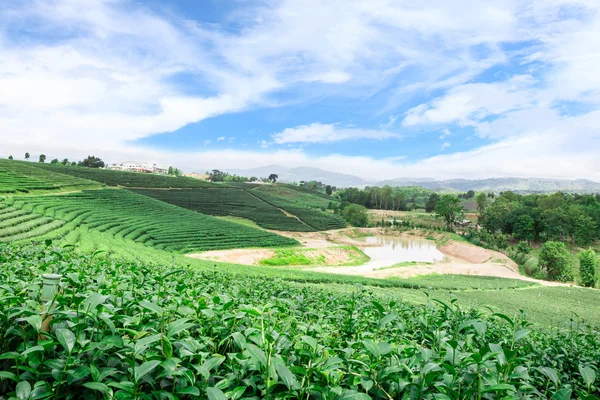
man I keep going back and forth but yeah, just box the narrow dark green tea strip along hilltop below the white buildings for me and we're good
[33,164,213,188]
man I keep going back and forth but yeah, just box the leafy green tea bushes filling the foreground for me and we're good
[0,244,600,400]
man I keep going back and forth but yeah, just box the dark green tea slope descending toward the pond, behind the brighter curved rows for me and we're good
[130,185,316,232]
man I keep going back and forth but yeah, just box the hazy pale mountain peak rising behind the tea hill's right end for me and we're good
[226,164,368,187]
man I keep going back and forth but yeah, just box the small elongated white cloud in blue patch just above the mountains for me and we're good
[273,122,400,144]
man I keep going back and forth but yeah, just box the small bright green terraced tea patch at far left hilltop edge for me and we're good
[0,160,100,193]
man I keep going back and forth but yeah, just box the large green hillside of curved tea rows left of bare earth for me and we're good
[0,189,298,252]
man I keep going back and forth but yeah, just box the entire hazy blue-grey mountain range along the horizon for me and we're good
[227,164,600,193]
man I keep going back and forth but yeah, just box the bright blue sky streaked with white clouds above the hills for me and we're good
[0,0,600,181]
